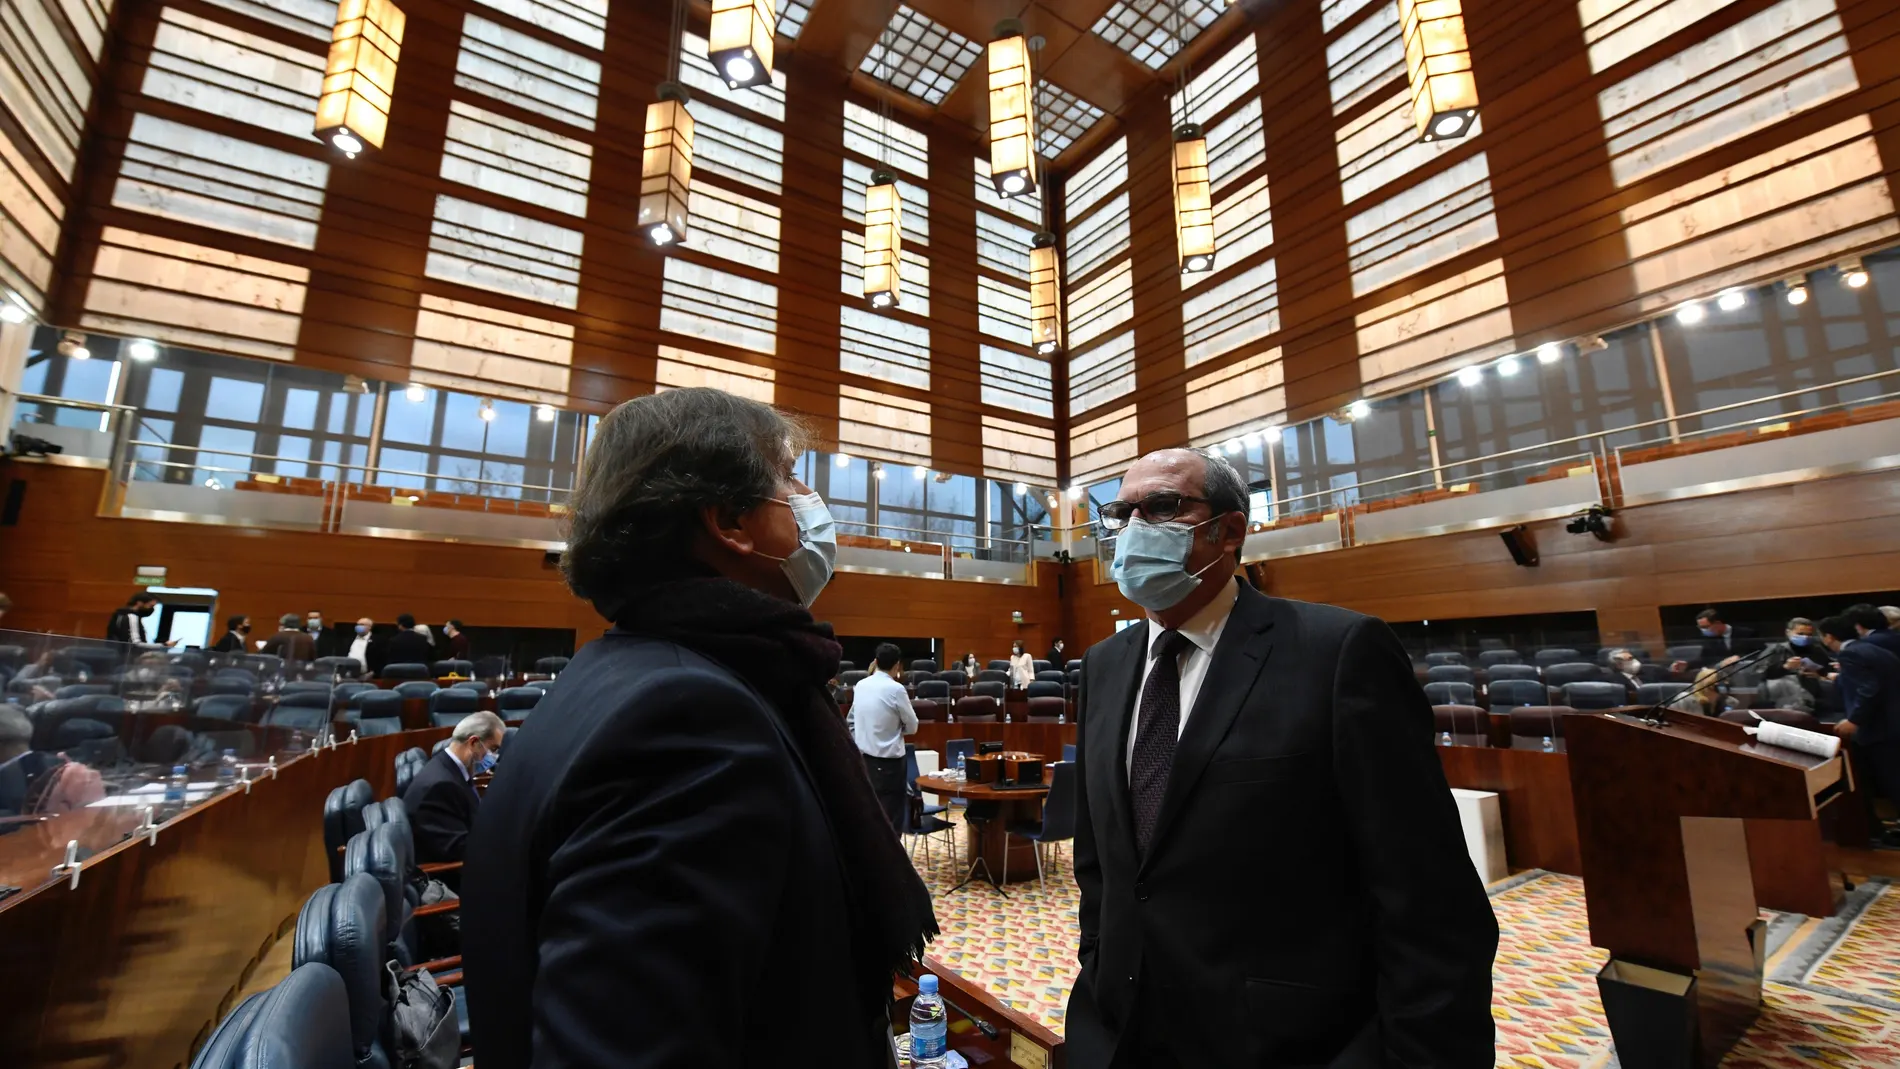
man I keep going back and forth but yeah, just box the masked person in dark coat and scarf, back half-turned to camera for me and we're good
[462,389,937,1069]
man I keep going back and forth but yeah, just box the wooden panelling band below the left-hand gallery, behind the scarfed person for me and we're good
[0,461,1062,661]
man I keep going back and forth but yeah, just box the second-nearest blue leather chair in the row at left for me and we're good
[291,872,390,1069]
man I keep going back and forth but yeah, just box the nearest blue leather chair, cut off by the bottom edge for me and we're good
[192,963,355,1069]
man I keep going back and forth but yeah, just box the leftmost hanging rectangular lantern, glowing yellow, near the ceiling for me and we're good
[315,0,407,159]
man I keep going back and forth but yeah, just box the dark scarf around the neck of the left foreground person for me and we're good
[616,575,937,1006]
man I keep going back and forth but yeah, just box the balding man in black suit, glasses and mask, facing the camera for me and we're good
[1068,450,1497,1069]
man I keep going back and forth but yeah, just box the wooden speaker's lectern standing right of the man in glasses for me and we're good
[1564,710,1851,1069]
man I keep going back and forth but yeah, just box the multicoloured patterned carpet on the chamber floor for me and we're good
[916,820,1900,1069]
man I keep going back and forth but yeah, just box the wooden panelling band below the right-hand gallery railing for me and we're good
[1070,473,1900,651]
